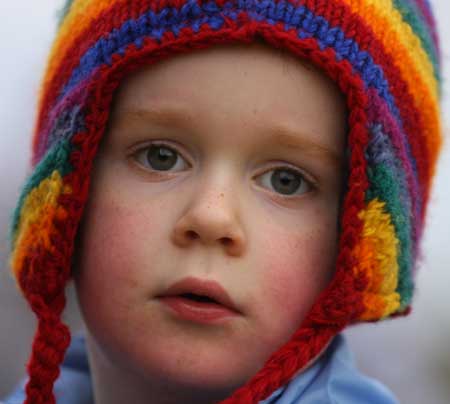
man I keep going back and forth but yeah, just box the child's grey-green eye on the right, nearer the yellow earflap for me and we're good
[255,166,314,196]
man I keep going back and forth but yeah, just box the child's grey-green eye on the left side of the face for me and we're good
[135,143,191,171]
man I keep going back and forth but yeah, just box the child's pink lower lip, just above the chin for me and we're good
[158,296,238,324]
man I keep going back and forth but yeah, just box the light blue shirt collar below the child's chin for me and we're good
[0,334,399,404]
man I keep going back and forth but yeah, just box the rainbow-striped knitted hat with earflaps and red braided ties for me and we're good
[10,0,442,404]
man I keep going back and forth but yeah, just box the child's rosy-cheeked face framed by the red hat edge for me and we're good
[75,44,346,398]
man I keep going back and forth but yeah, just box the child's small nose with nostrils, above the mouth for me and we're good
[172,191,246,256]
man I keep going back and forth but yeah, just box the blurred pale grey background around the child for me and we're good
[0,0,450,404]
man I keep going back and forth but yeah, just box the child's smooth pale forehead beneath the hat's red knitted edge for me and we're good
[107,43,346,163]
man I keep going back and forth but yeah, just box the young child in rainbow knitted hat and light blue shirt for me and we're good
[0,0,442,404]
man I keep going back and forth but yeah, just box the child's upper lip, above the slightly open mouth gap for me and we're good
[157,277,239,312]
